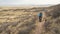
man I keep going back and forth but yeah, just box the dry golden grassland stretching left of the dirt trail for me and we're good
[0,8,37,34]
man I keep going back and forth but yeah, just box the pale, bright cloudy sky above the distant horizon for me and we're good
[0,0,60,6]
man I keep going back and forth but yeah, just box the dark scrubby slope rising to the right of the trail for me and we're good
[43,4,60,34]
